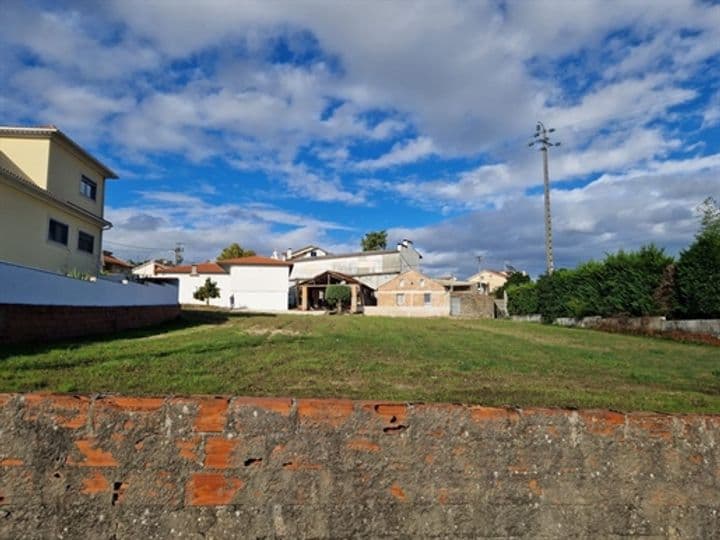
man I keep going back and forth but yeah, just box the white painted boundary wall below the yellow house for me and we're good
[0,261,178,307]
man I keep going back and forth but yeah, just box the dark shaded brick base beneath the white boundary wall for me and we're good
[0,304,180,343]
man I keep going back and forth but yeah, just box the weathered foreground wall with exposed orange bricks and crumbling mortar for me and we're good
[0,394,720,538]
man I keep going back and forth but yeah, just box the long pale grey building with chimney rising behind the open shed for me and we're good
[286,240,422,305]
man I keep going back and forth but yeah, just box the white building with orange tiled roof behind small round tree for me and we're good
[157,256,292,311]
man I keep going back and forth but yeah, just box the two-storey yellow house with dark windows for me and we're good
[0,126,117,275]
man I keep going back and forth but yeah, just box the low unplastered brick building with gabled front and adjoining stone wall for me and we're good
[365,270,494,318]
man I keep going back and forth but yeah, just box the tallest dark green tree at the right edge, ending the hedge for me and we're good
[675,197,720,318]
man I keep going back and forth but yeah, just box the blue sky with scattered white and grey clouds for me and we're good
[0,0,720,276]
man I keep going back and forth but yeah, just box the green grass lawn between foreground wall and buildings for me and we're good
[0,311,720,413]
